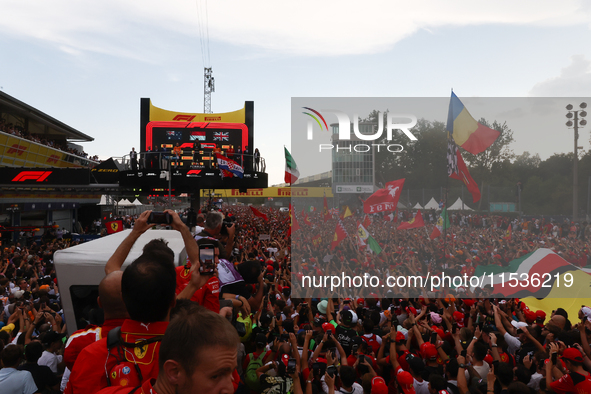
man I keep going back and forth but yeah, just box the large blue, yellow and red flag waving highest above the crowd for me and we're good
[447,92,501,155]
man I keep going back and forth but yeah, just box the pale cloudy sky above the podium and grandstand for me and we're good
[0,0,591,184]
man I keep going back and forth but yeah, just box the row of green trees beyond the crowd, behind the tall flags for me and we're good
[365,111,591,217]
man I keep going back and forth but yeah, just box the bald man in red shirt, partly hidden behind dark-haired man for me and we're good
[64,271,129,370]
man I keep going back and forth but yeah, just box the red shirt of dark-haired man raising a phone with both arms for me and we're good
[64,319,168,394]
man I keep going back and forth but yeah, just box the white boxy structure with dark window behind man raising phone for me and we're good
[54,229,187,335]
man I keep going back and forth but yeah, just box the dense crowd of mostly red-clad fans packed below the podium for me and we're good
[0,207,591,394]
